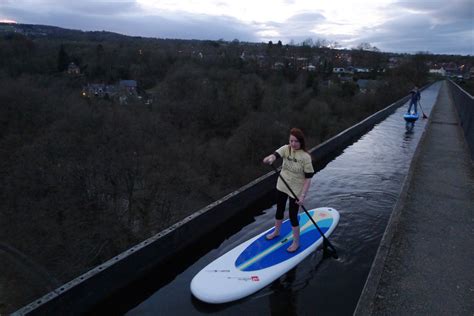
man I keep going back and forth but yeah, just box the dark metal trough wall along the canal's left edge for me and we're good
[13,87,418,315]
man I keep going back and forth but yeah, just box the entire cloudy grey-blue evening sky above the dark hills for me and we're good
[0,0,474,56]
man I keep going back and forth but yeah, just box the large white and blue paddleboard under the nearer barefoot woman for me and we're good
[191,207,339,304]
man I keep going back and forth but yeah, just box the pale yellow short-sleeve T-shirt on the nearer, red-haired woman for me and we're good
[275,145,314,198]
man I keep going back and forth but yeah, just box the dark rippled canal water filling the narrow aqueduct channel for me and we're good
[107,83,441,316]
